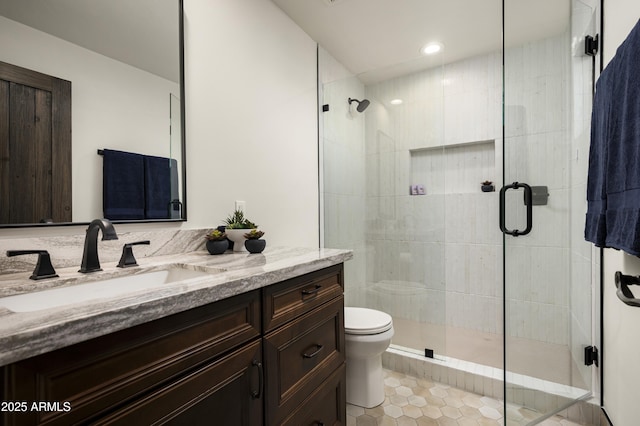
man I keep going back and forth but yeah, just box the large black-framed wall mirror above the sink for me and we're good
[0,0,186,228]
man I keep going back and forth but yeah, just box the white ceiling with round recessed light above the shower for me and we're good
[272,0,570,84]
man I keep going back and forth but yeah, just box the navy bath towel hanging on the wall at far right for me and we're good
[585,22,640,256]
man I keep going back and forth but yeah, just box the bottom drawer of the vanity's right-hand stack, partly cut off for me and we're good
[282,364,347,426]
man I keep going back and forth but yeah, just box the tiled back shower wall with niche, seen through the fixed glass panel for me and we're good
[366,54,502,342]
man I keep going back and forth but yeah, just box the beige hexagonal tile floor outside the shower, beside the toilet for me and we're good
[347,369,582,426]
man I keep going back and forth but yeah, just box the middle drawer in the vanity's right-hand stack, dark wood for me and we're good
[264,297,345,424]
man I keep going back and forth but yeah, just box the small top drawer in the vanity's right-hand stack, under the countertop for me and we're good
[263,264,344,332]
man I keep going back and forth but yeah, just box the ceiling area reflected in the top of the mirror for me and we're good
[0,0,180,82]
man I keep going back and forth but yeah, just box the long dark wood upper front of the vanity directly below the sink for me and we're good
[0,291,261,426]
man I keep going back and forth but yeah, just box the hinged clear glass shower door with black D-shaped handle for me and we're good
[500,0,595,424]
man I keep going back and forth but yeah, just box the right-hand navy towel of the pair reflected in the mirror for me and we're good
[144,155,171,219]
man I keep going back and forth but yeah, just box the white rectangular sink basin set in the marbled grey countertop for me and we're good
[0,267,211,312]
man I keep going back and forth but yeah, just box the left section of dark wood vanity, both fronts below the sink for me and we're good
[2,291,262,426]
